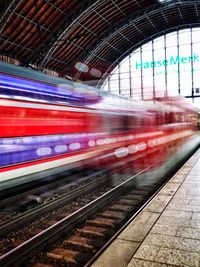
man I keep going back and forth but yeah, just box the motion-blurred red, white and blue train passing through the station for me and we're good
[0,62,199,190]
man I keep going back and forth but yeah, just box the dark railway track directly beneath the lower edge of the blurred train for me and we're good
[0,155,148,236]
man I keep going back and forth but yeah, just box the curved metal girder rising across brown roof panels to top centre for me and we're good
[35,0,102,69]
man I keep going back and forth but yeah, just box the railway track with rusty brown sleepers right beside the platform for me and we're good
[0,161,167,267]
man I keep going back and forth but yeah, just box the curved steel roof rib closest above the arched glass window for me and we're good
[75,0,199,79]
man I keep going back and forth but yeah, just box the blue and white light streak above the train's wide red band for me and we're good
[0,73,99,104]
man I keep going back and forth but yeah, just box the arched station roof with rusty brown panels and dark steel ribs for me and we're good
[0,0,200,80]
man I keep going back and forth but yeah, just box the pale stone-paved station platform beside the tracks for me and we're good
[92,149,200,267]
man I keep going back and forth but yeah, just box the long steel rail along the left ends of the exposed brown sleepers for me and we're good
[0,161,160,267]
